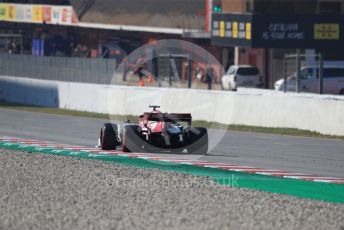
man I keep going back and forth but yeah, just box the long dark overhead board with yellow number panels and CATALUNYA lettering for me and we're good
[212,14,344,49]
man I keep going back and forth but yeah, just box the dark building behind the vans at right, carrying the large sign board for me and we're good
[212,0,344,88]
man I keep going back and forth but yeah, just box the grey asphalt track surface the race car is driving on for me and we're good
[0,109,344,177]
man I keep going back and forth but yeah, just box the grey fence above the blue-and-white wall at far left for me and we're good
[0,54,116,84]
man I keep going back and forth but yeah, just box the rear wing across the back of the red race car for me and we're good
[144,113,192,125]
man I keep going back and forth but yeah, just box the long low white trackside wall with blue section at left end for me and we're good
[0,76,344,135]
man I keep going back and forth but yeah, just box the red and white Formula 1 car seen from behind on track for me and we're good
[99,105,208,155]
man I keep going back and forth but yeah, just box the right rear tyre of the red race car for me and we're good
[187,127,209,155]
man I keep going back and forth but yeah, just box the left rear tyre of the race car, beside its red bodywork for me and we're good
[121,125,143,152]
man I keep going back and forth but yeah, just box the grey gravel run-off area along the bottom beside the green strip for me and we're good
[0,149,344,230]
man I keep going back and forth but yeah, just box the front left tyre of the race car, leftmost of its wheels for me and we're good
[100,123,119,150]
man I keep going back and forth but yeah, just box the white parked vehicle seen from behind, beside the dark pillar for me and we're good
[221,65,262,90]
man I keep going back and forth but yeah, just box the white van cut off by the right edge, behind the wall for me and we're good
[274,65,344,95]
